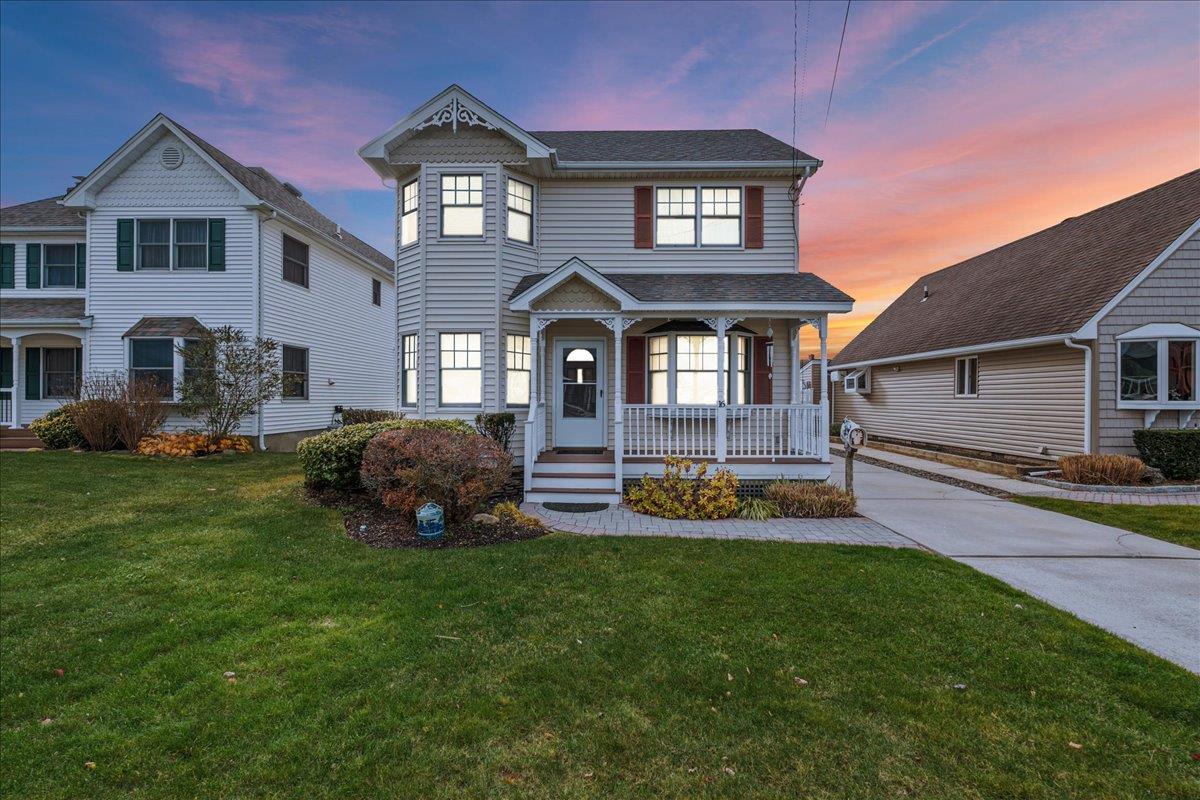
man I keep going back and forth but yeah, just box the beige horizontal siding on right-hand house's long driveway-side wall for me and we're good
[832,344,1084,458]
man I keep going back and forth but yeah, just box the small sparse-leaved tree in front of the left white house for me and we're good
[179,325,283,445]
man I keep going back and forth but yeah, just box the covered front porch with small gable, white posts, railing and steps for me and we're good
[512,265,840,503]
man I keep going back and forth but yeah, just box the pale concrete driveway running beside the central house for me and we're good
[834,458,1200,674]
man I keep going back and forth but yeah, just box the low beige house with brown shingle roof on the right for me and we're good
[833,170,1200,458]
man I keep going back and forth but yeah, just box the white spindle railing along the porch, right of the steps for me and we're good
[622,404,823,461]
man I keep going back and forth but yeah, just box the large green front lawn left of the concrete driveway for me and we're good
[0,453,1200,799]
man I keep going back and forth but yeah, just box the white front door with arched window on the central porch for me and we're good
[554,339,607,447]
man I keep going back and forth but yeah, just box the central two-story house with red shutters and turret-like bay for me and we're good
[359,86,852,503]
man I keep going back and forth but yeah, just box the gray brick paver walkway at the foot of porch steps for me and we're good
[522,503,916,547]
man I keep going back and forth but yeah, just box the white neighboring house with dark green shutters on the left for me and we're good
[0,114,396,449]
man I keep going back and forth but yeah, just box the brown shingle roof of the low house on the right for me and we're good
[834,169,1200,365]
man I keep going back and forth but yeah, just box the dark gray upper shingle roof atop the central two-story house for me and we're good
[530,128,812,162]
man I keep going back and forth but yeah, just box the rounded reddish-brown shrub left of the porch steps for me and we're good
[352,428,512,522]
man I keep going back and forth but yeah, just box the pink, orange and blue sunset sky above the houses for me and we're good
[0,1,1200,349]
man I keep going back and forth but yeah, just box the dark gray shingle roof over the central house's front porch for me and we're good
[509,272,853,308]
